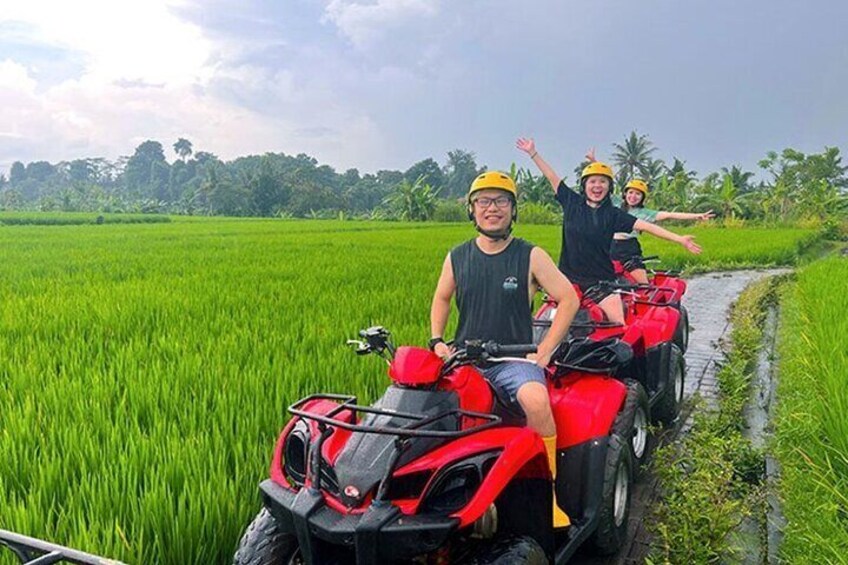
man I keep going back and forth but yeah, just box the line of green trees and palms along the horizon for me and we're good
[0,132,848,223]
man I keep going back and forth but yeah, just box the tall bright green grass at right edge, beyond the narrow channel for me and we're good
[774,258,848,563]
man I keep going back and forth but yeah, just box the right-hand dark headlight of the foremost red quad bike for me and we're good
[421,451,500,514]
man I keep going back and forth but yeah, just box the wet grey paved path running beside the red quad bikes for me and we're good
[572,269,788,565]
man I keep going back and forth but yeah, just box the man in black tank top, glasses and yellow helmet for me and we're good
[430,171,579,527]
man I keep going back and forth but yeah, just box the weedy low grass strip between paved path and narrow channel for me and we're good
[649,278,776,563]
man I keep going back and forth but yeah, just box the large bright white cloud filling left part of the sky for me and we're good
[0,0,392,172]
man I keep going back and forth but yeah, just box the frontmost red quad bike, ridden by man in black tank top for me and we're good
[234,327,632,565]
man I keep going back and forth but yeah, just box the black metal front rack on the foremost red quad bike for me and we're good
[289,394,501,439]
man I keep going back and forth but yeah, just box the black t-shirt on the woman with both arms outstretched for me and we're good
[557,181,636,286]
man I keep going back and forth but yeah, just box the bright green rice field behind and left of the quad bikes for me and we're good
[0,218,820,564]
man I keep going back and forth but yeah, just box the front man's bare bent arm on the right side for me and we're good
[530,247,580,367]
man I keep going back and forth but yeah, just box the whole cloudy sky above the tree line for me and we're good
[0,0,848,176]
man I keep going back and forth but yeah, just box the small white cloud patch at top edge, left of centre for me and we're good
[325,0,440,47]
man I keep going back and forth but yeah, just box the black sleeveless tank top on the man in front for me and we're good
[450,238,533,345]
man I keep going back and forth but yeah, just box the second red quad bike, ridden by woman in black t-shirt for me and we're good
[533,283,686,476]
